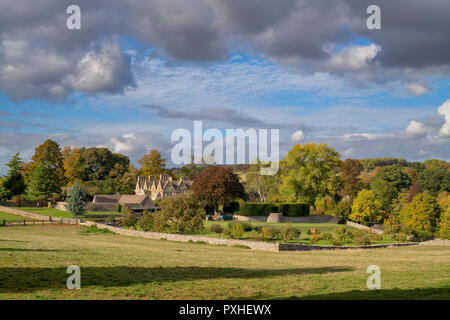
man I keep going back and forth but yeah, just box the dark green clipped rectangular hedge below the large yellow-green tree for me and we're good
[237,202,309,217]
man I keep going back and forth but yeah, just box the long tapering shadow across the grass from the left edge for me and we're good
[0,266,354,293]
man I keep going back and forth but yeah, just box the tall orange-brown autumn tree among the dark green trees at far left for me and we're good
[30,139,66,193]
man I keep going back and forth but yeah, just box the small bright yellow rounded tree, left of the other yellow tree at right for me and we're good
[349,189,384,222]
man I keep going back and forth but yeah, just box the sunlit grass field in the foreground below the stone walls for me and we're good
[0,225,450,299]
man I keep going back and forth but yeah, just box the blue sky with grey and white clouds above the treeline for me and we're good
[0,0,450,173]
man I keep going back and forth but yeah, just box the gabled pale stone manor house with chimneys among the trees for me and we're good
[134,174,192,200]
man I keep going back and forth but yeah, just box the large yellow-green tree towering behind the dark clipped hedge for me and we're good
[279,143,340,206]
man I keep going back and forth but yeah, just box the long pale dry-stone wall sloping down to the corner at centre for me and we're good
[85,221,279,252]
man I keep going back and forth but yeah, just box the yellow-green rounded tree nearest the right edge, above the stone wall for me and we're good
[400,193,441,233]
